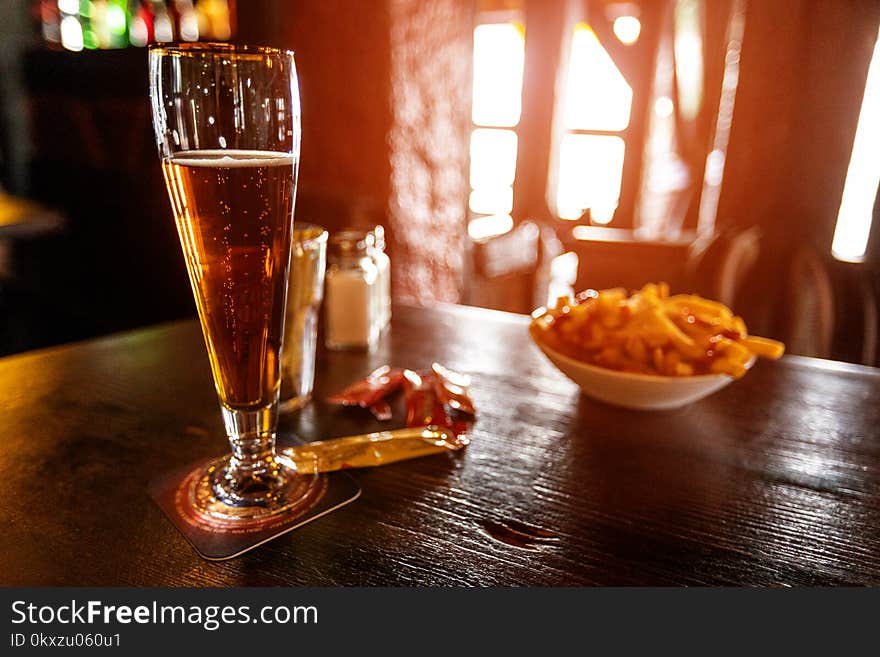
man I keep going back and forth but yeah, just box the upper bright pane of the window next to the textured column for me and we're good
[472,23,525,128]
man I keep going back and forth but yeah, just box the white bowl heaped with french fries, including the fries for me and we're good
[529,283,785,410]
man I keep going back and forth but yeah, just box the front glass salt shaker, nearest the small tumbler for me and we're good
[324,230,380,349]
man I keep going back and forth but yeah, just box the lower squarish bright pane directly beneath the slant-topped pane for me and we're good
[556,135,624,224]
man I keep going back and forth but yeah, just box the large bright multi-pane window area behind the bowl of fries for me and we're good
[469,0,745,240]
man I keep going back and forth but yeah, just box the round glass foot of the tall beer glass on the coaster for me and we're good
[190,456,324,524]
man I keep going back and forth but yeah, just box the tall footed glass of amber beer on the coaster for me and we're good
[149,44,308,520]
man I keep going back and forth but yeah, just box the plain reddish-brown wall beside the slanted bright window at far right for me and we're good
[718,0,880,250]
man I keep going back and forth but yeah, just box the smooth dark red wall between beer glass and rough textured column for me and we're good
[238,0,391,229]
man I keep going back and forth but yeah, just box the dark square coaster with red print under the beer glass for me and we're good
[148,459,361,561]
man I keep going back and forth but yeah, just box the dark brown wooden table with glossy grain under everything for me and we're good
[0,307,880,586]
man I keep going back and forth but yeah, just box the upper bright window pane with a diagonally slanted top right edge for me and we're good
[564,23,632,131]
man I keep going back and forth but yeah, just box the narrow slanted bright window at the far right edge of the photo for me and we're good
[831,27,880,262]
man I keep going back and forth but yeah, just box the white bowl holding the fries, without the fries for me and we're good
[529,320,755,411]
